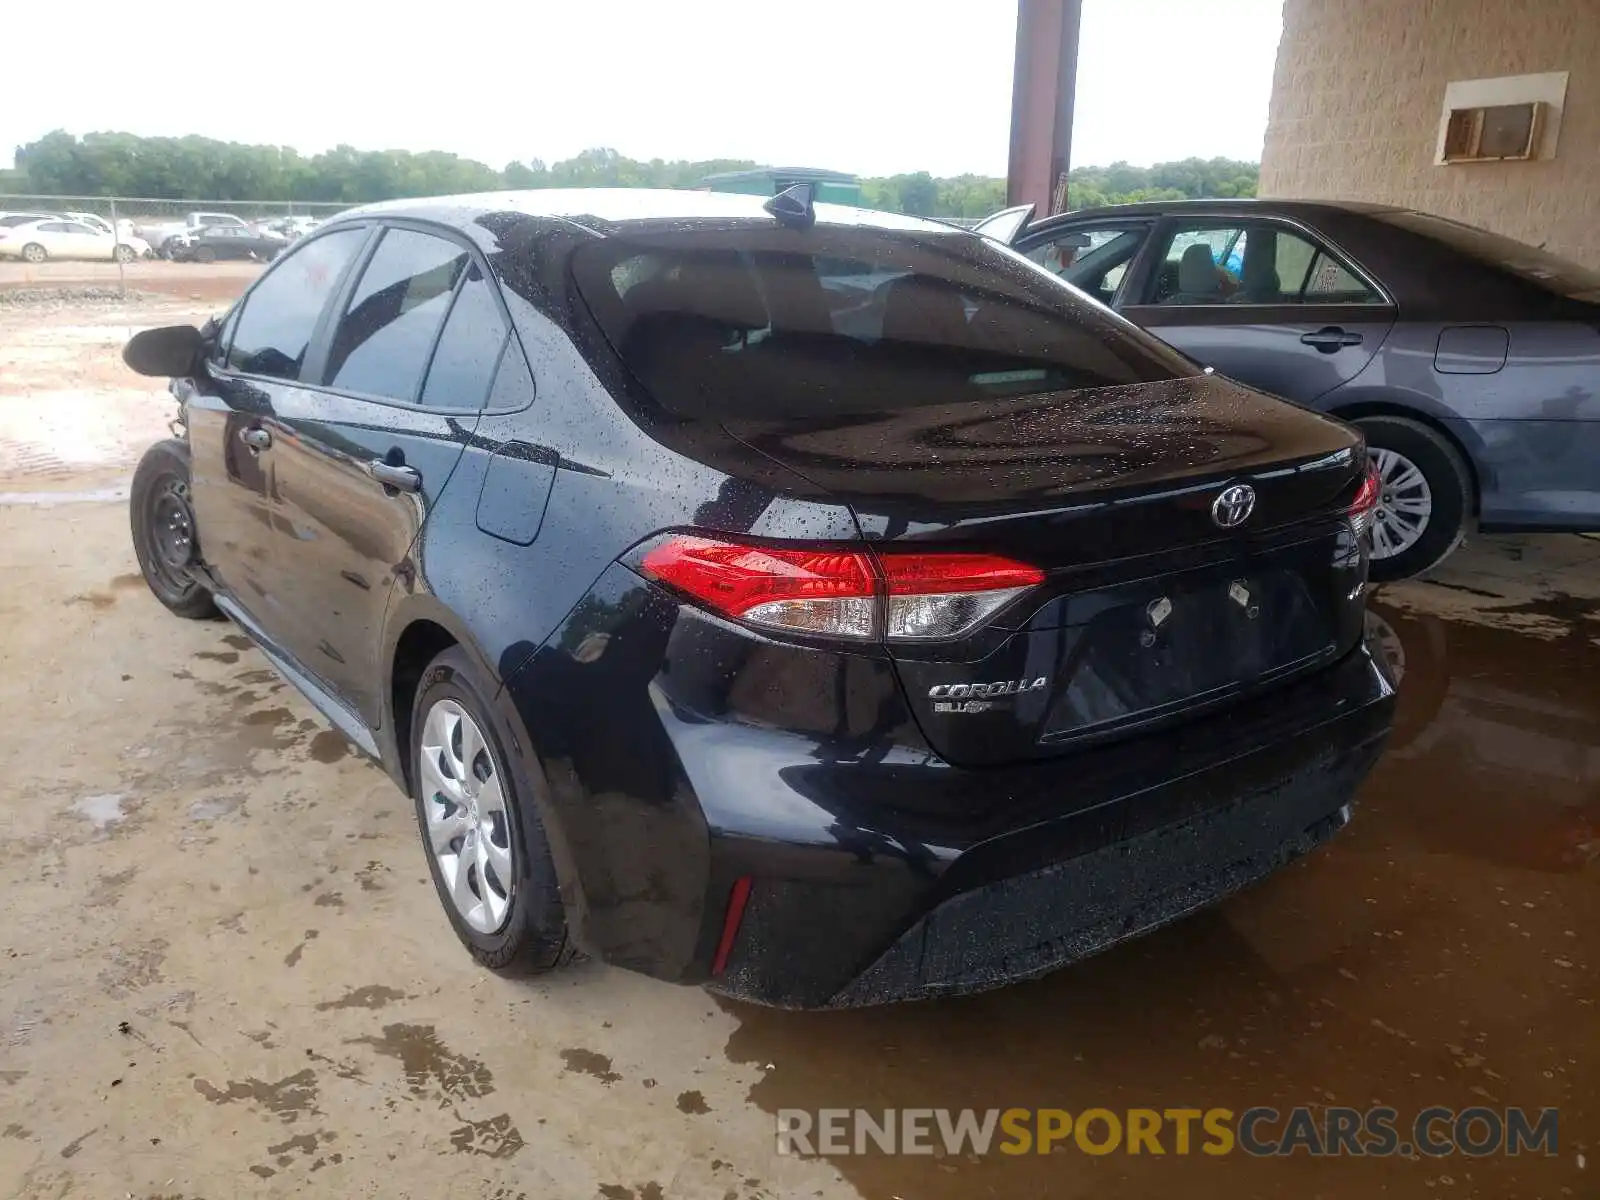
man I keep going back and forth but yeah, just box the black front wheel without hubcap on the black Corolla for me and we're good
[128,438,219,621]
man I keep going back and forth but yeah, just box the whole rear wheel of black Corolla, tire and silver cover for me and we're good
[410,646,574,974]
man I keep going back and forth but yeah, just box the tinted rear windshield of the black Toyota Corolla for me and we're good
[573,224,1195,419]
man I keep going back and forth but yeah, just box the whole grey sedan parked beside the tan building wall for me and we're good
[992,200,1600,579]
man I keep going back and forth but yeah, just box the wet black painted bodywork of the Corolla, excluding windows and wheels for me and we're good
[159,188,1392,1006]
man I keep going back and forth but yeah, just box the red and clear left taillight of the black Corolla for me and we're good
[640,534,1045,642]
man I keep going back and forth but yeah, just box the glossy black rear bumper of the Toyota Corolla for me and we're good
[507,576,1394,1008]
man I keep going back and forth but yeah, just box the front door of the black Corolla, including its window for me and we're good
[184,229,370,624]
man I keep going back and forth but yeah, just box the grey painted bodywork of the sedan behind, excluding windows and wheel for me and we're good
[1016,200,1600,531]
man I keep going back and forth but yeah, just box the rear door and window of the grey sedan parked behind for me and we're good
[1118,216,1395,403]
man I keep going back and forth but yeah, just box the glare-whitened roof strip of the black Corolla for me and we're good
[326,187,952,234]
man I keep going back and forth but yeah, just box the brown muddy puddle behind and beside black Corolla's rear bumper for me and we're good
[718,606,1600,1200]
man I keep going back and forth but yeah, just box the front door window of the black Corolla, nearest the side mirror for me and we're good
[227,229,366,379]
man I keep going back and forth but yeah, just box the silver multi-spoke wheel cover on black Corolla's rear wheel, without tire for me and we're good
[418,699,515,933]
